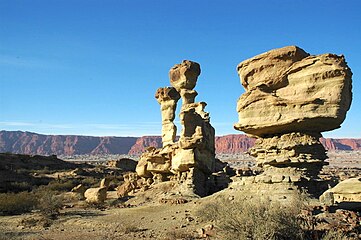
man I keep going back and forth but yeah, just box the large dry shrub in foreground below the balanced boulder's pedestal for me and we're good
[196,194,303,240]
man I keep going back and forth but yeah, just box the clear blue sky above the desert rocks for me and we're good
[0,0,361,138]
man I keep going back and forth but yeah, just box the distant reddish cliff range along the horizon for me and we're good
[0,131,361,155]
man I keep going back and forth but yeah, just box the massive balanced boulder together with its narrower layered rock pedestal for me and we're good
[234,46,352,195]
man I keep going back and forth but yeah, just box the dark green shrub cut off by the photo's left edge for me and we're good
[0,192,37,215]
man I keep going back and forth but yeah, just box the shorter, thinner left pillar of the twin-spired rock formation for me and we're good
[155,87,180,147]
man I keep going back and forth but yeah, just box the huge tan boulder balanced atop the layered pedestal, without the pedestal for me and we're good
[235,46,352,137]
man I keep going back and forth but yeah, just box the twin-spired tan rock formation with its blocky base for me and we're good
[136,60,215,195]
